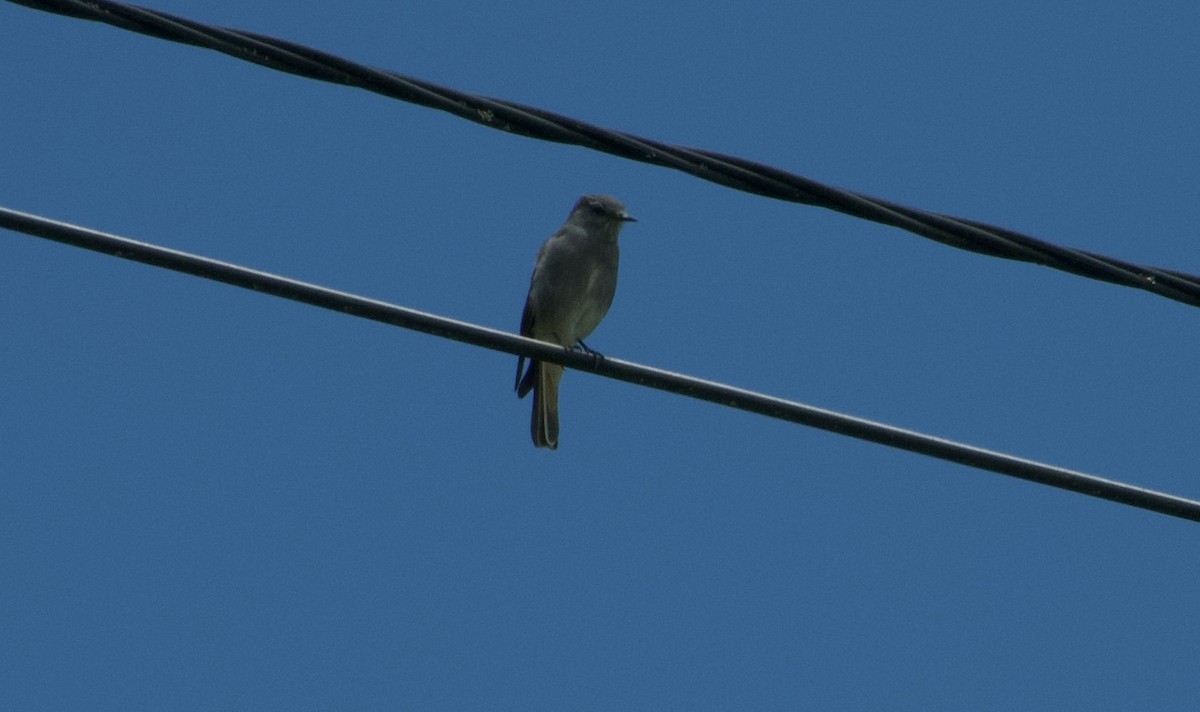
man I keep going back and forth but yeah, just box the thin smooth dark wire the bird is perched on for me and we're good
[0,208,1200,521]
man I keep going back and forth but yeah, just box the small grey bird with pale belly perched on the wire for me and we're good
[515,195,637,450]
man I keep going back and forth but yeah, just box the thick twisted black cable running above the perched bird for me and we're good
[10,0,1200,306]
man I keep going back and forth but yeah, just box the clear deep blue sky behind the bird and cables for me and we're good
[0,0,1200,710]
